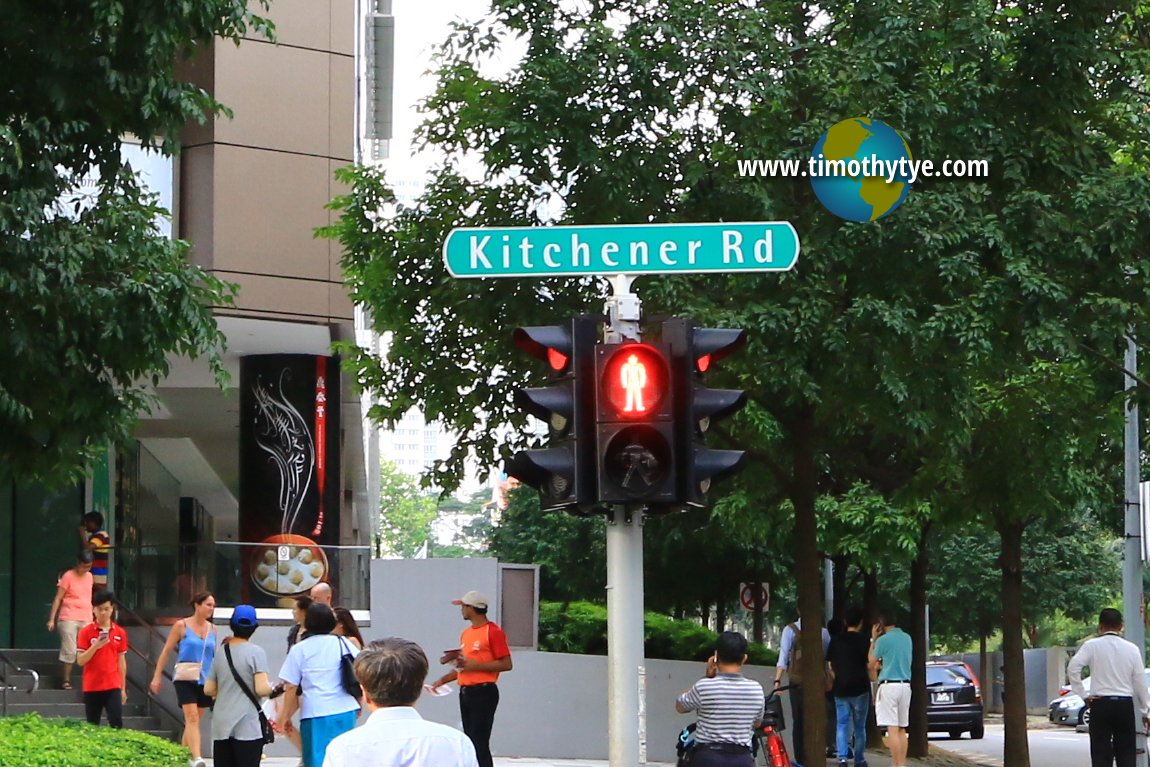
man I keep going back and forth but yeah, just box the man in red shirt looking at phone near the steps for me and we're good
[76,591,128,729]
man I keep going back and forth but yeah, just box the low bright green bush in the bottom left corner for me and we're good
[0,714,189,767]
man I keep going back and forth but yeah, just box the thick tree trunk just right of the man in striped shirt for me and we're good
[790,406,827,765]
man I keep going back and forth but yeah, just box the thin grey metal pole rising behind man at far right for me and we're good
[1122,336,1145,655]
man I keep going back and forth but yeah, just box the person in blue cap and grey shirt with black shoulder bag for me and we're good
[204,605,275,767]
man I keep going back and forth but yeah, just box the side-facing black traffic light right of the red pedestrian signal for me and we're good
[662,319,746,508]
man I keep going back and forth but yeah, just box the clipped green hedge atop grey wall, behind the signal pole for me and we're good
[539,601,779,666]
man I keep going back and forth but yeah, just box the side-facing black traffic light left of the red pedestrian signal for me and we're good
[506,315,600,513]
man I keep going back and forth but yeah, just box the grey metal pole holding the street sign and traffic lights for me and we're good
[605,275,646,767]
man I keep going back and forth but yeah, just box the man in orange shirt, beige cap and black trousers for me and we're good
[431,591,511,767]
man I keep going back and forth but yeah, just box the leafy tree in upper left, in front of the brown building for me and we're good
[0,0,270,480]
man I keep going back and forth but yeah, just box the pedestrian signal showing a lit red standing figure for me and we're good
[595,343,676,504]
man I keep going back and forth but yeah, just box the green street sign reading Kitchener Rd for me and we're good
[443,221,799,278]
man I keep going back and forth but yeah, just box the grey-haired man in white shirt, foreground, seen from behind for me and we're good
[323,637,478,767]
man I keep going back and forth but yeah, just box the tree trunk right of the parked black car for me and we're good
[997,520,1030,767]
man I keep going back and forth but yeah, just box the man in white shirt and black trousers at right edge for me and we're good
[1066,607,1150,767]
